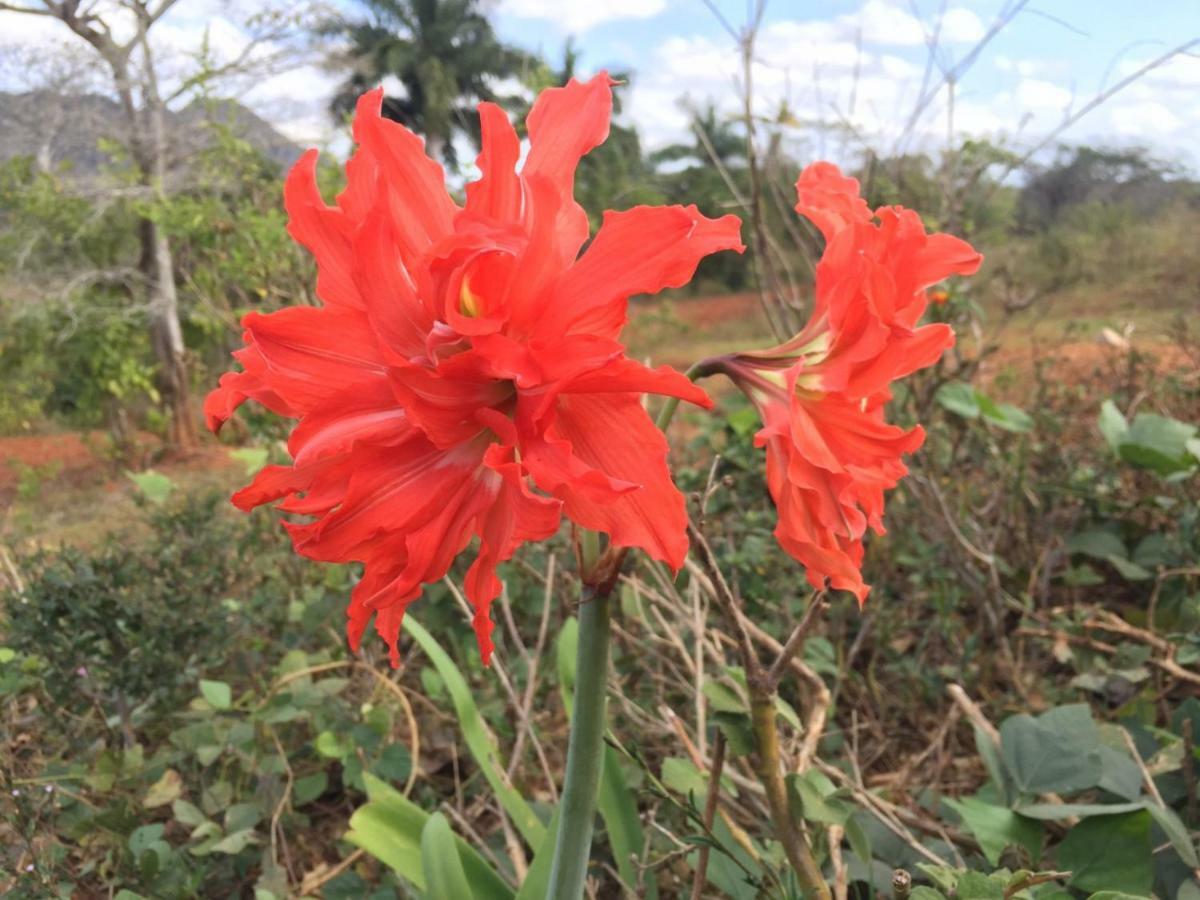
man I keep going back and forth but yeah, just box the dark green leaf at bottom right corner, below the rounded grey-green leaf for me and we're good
[1057,810,1154,895]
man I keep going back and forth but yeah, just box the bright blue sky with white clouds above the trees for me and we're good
[0,0,1200,170]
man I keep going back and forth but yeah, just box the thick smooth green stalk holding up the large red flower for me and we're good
[546,586,610,900]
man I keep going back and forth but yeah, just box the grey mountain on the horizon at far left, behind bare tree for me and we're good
[0,91,301,180]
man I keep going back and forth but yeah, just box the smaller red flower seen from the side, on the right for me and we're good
[709,162,983,602]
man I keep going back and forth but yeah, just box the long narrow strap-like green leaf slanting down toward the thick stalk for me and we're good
[404,616,546,847]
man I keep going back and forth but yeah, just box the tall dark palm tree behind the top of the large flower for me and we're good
[320,0,530,164]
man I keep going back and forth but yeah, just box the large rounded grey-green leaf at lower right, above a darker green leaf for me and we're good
[1000,703,1103,793]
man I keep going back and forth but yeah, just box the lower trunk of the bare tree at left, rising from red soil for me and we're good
[142,218,198,450]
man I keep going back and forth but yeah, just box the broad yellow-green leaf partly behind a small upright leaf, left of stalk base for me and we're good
[346,772,512,900]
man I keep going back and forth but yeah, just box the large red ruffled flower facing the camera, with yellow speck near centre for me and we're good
[205,74,742,665]
